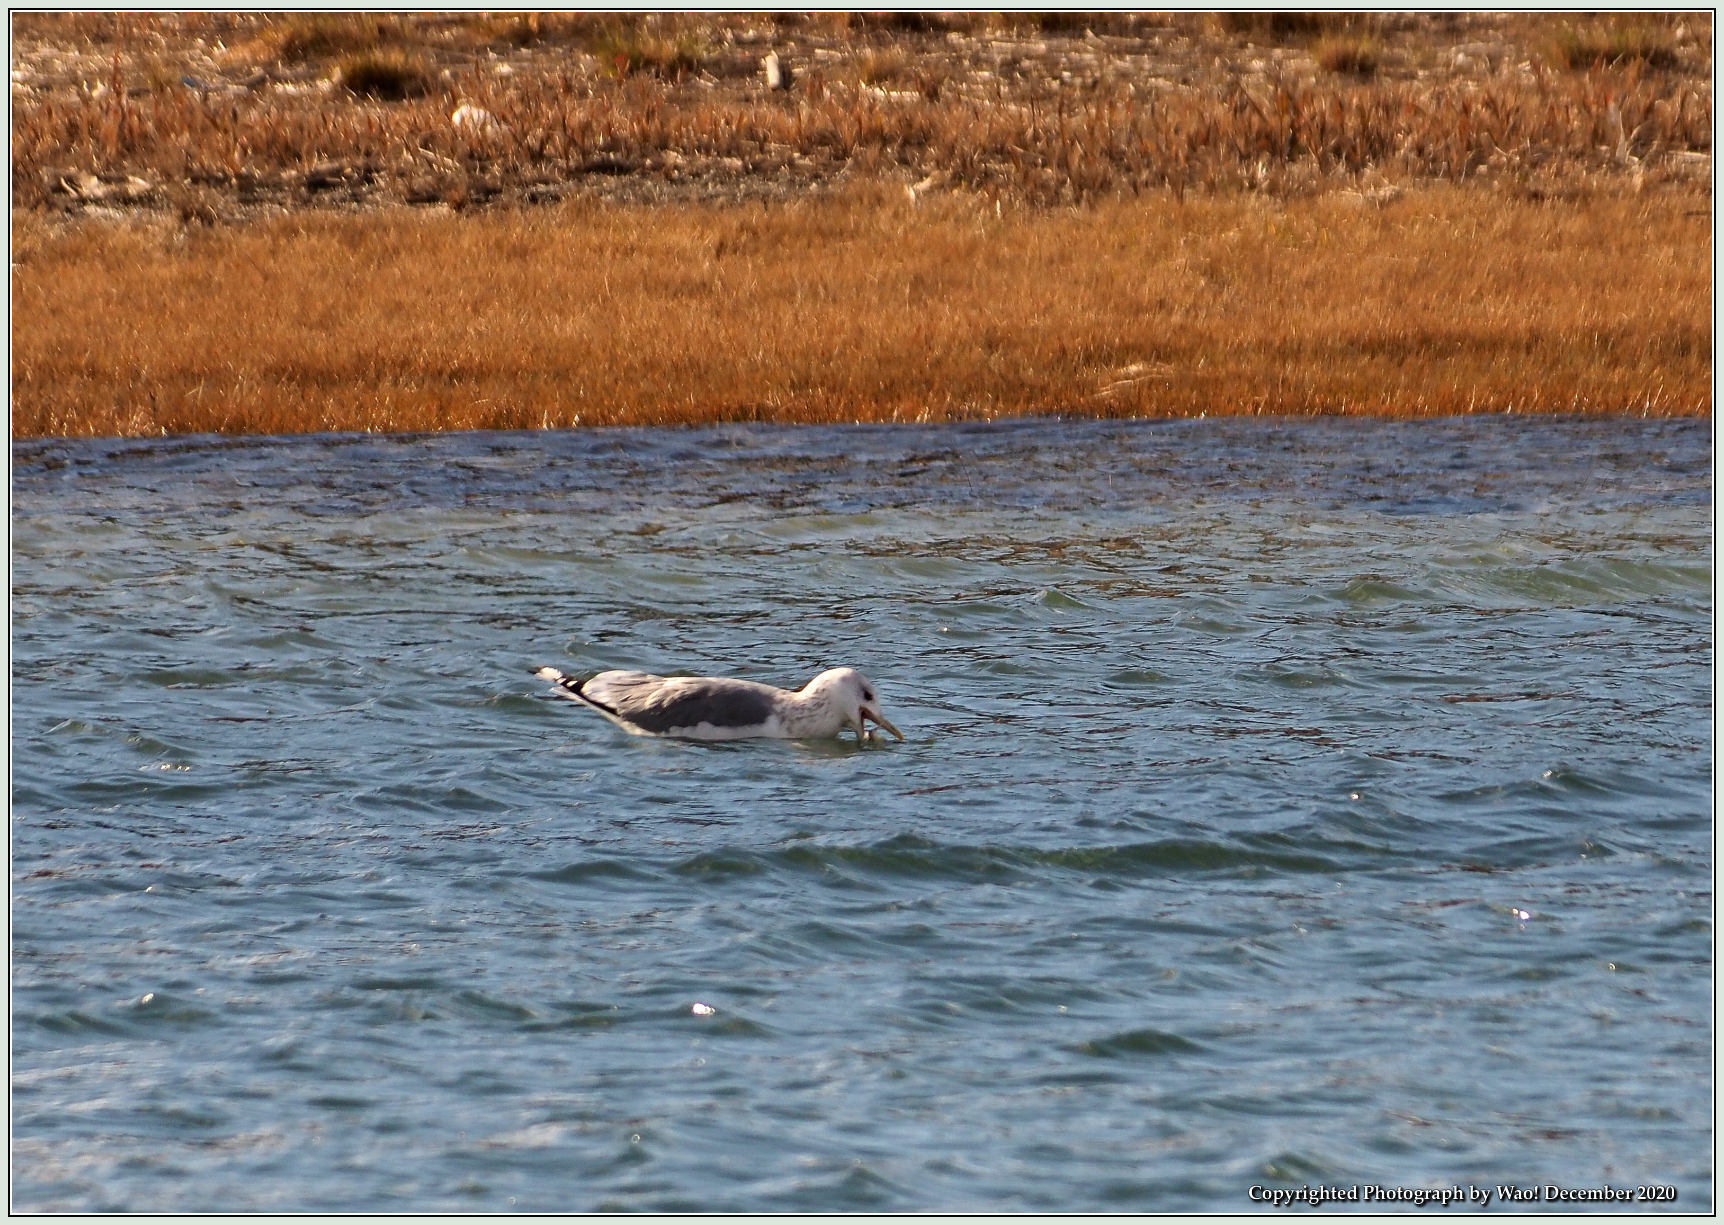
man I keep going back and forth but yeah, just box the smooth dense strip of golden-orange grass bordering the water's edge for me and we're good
[12,186,1712,436]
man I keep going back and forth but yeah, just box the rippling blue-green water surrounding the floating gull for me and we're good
[12,417,1714,1211]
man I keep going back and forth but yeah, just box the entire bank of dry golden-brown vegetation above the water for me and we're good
[12,14,1712,438]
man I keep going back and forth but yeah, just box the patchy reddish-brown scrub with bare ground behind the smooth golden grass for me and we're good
[12,12,1712,214]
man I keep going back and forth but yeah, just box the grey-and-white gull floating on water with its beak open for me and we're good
[533,668,903,743]
